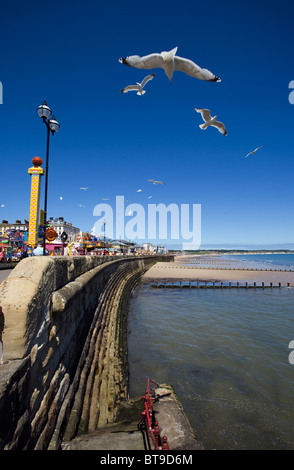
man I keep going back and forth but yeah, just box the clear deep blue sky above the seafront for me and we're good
[0,0,294,250]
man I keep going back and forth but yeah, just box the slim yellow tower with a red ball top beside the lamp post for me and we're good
[28,157,45,246]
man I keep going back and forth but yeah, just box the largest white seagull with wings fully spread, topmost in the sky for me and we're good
[119,47,221,82]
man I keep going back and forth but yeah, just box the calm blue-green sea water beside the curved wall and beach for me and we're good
[128,254,294,450]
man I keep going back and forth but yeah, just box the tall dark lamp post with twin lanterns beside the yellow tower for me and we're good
[37,101,60,255]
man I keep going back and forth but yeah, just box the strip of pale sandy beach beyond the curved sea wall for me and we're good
[143,257,294,287]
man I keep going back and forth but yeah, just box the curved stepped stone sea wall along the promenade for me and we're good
[0,256,173,450]
